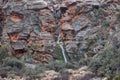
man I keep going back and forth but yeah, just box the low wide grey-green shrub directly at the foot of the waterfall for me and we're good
[36,60,78,72]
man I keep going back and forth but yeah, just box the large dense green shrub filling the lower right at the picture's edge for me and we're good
[89,45,120,78]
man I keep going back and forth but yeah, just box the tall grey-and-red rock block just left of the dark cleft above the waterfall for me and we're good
[39,9,56,33]
